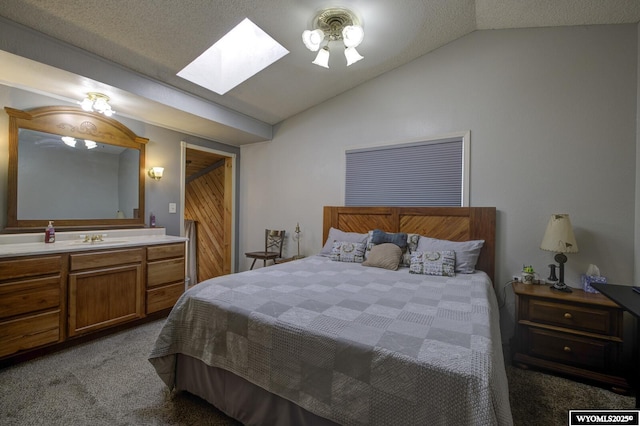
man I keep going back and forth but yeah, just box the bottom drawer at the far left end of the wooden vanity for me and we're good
[0,311,60,357]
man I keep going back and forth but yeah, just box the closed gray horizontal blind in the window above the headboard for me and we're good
[345,137,464,207]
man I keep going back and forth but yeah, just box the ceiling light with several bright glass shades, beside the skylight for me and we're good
[302,7,364,68]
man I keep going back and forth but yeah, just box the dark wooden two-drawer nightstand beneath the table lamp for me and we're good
[513,282,630,393]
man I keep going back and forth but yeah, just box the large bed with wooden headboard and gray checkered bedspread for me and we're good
[149,207,512,425]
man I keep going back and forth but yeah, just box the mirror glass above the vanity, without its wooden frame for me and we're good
[17,129,140,220]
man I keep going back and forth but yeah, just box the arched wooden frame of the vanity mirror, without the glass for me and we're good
[3,106,149,232]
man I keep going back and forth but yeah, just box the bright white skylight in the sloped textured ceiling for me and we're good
[177,18,289,95]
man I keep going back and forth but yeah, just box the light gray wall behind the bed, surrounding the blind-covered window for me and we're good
[240,25,638,338]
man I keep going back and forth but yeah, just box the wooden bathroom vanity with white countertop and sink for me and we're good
[0,228,186,363]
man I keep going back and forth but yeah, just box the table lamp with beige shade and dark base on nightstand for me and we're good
[540,214,578,293]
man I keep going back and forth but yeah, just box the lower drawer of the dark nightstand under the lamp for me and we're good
[527,327,618,371]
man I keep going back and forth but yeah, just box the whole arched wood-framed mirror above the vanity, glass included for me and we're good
[5,106,148,232]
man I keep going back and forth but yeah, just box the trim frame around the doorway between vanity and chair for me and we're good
[179,141,237,274]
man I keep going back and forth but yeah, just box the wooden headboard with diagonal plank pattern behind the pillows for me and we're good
[322,206,496,283]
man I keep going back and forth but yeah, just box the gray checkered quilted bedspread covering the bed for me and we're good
[149,256,512,425]
